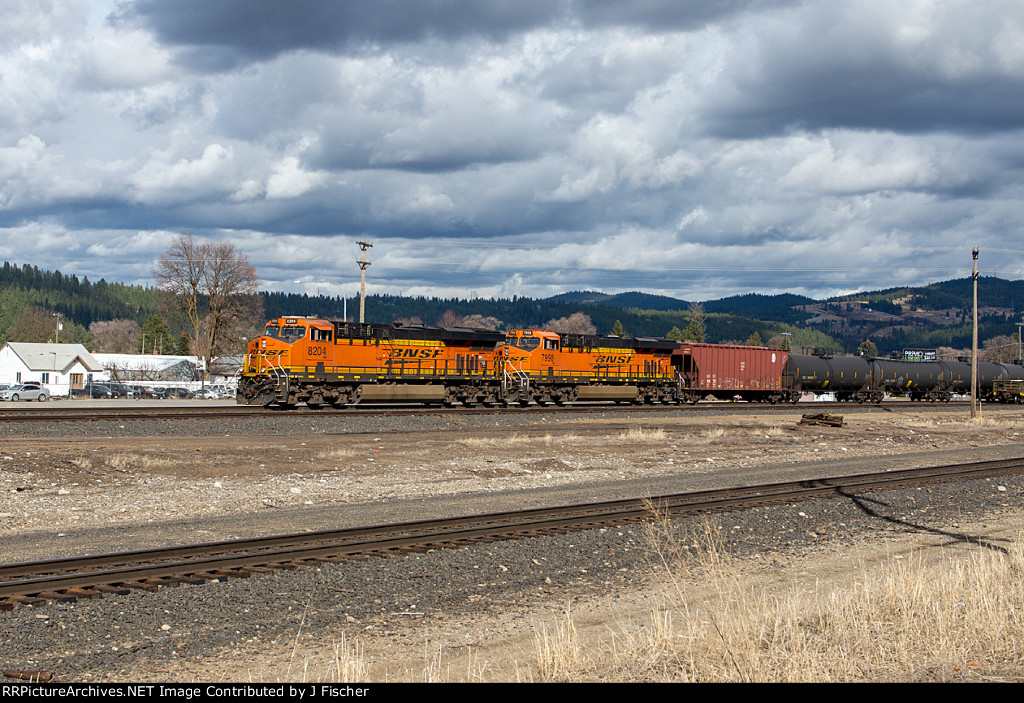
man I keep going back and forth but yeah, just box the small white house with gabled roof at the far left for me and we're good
[0,342,103,396]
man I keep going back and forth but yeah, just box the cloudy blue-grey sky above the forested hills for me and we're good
[0,0,1024,300]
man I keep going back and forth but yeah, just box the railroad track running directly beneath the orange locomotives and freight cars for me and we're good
[0,401,965,424]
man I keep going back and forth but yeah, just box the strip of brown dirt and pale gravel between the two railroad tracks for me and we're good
[0,406,1024,540]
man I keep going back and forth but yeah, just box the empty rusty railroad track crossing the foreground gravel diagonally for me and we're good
[0,457,1024,610]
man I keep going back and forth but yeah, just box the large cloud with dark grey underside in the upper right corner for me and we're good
[701,3,1024,138]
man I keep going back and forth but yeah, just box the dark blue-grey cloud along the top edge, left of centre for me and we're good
[121,0,796,71]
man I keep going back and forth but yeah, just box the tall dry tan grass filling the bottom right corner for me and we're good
[602,521,1024,682]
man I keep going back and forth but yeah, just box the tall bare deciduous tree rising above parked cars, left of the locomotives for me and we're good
[153,232,263,376]
